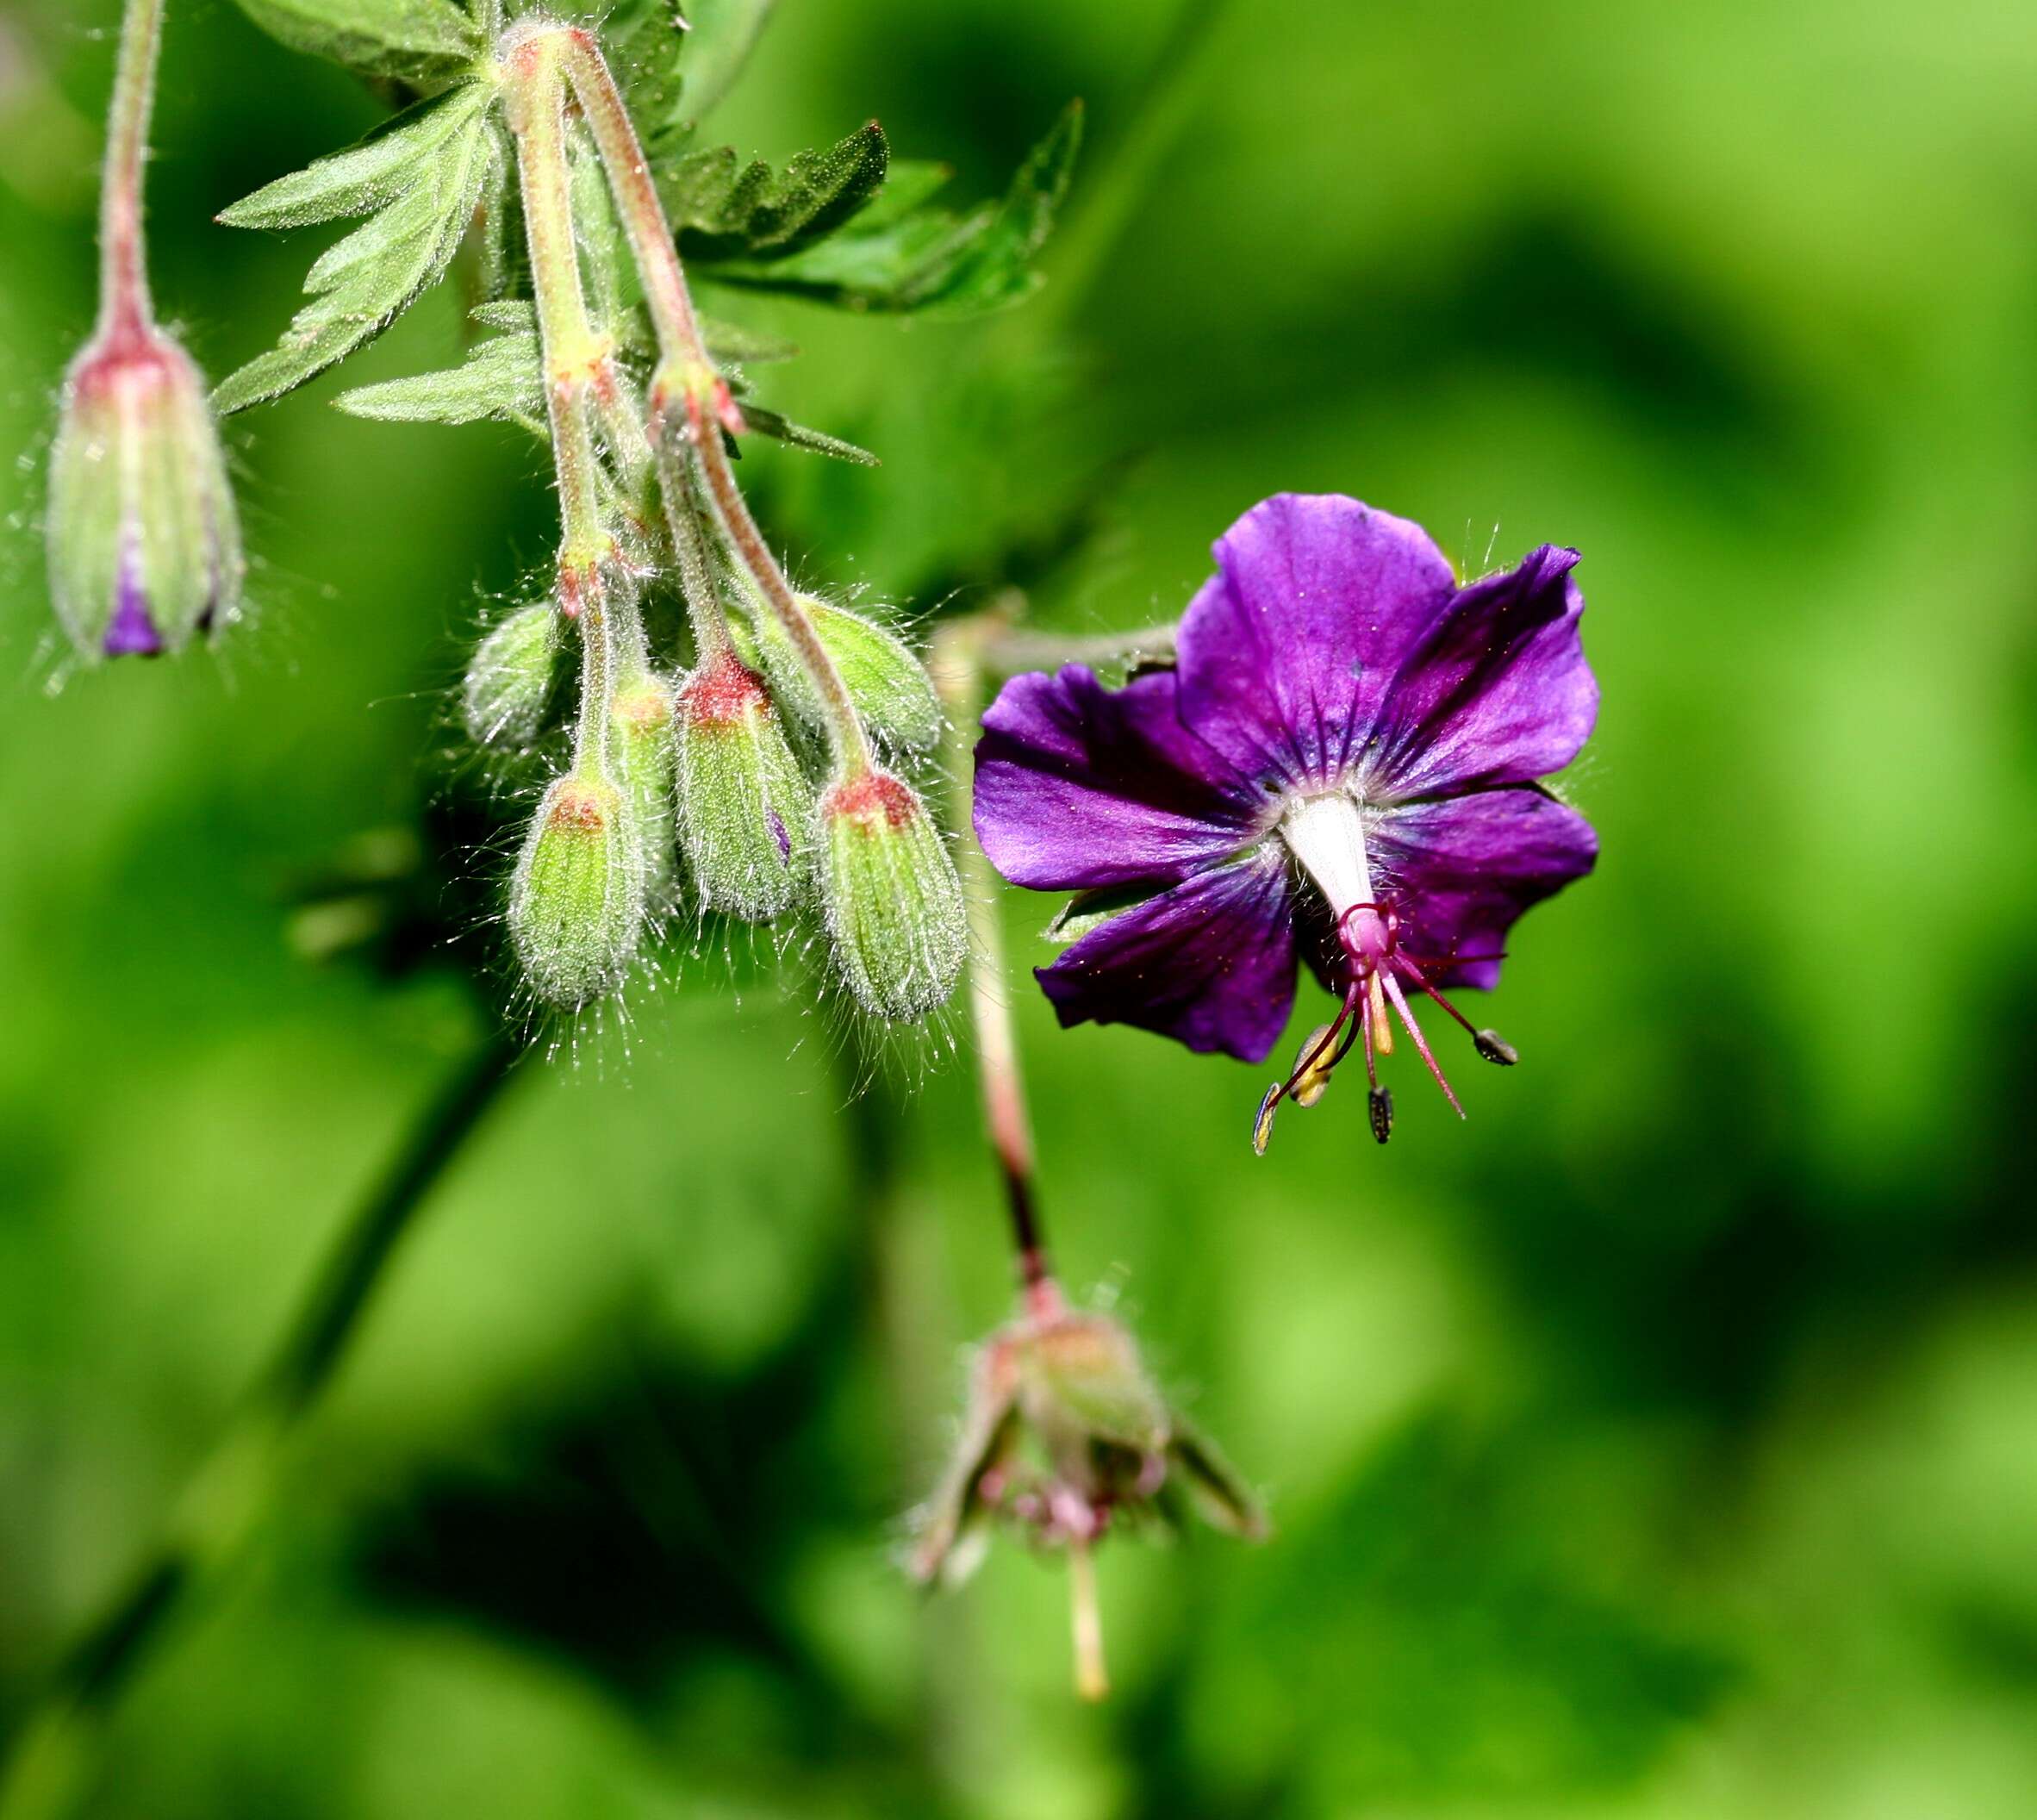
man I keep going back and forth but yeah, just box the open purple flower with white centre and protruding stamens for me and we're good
[975,493,1599,1148]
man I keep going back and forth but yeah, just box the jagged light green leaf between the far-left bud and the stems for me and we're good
[212,84,491,414]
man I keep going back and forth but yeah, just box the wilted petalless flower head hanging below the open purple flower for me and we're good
[911,1280,1265,1698]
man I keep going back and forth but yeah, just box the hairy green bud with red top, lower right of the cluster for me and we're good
[821,769,968,1023]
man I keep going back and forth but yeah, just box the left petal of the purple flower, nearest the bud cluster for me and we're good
[975,664,1261,891]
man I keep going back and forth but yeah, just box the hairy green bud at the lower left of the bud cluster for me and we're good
[509,776,644,1011]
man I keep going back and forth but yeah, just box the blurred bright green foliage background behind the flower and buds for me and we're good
[0,0,2037,1820]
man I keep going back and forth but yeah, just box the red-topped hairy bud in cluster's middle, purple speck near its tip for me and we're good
[676,650,813,923]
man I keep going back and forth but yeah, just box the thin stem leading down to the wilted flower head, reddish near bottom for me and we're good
[933,618,1053,1311]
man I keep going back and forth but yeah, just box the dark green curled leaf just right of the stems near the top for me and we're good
[660,121,888,261]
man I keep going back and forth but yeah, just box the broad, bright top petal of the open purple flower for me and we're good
[1180,493,1456,787]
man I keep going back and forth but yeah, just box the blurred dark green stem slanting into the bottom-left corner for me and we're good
[0,1033,517,1820]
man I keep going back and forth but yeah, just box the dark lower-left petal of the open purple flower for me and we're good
[1035,842,1296,1062]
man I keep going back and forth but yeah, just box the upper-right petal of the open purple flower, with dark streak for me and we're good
[1361,544,1599,801]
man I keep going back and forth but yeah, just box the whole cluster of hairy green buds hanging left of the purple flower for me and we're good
[460,545,968,1023]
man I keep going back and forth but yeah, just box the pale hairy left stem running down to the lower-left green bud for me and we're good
[501,33,615,778]
